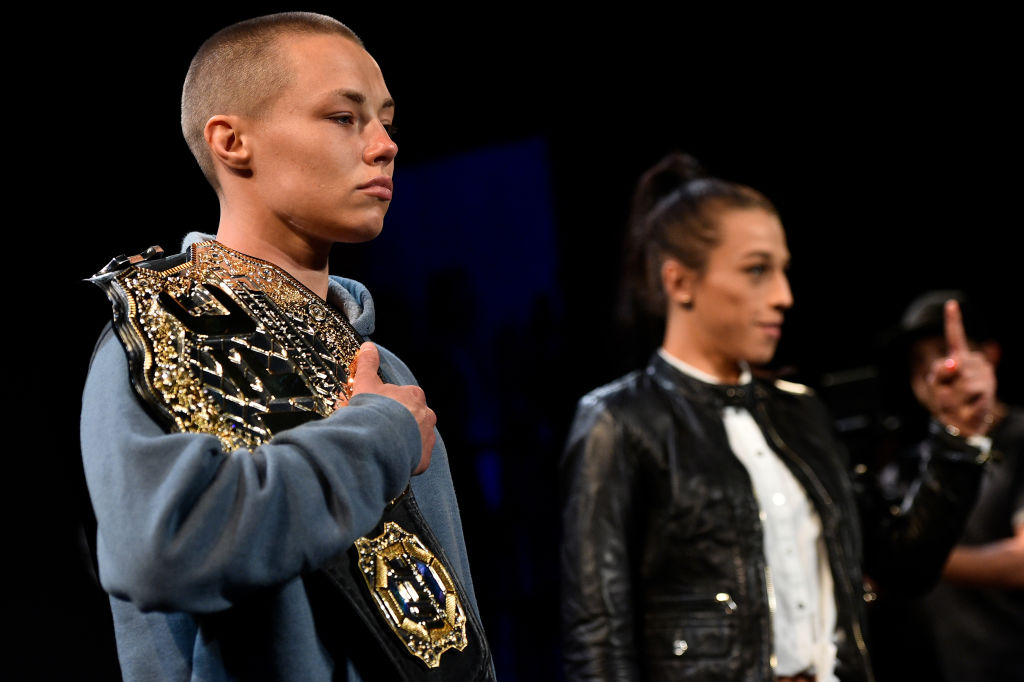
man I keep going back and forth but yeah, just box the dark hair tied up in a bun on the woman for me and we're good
[625,152,778,319]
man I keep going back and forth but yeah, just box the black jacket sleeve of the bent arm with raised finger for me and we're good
[855,413,986,596]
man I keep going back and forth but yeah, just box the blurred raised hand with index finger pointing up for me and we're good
[928,300,995,436]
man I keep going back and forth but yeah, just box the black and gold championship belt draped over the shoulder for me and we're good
[89,241,490,680]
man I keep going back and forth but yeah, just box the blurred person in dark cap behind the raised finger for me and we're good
[870,290,1024,682]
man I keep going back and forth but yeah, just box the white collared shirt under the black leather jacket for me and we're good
[658,348,837,682]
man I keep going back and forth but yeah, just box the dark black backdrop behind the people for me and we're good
[19,3,1024,680]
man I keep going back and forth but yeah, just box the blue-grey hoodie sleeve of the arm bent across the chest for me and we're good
[74,328,421,612]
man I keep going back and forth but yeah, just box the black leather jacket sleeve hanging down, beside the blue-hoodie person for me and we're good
[560,397,639,681]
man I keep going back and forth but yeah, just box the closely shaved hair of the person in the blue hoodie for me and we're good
[181,12,364,189]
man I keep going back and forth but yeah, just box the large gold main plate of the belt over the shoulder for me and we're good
[96,241,361,452]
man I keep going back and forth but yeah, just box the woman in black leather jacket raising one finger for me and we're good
[561,155,994,682]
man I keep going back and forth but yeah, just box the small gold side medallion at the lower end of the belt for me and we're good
[355,521,467,668]
